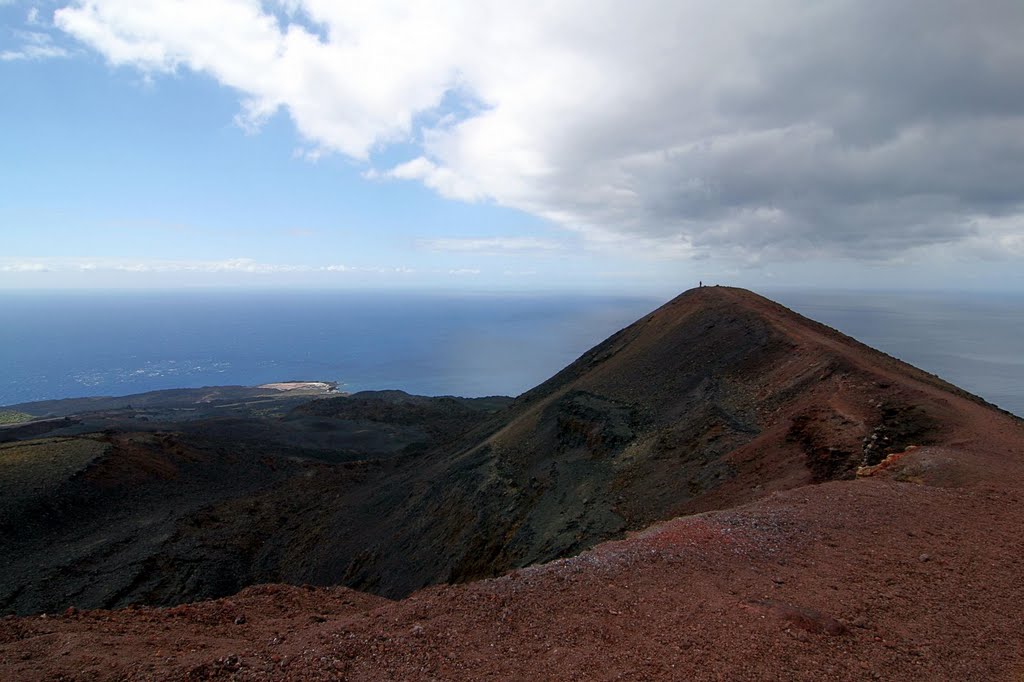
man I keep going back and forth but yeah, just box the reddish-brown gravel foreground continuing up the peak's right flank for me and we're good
[0,290,1024,680]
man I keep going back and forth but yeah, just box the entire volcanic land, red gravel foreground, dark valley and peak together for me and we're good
[0,296,1024,679]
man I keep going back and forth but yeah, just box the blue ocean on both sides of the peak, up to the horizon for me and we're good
[0,291,1024,415]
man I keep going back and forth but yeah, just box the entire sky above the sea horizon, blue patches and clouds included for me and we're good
[0,0,1024,295]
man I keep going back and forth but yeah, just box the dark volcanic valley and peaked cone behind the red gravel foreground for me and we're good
[0,287,1011,612]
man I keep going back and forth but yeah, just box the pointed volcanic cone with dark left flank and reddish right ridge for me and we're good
[331,287,1014,596]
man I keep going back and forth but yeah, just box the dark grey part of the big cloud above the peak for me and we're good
[548,2,1024,258]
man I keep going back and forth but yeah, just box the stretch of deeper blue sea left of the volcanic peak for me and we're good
[0,292,658,404]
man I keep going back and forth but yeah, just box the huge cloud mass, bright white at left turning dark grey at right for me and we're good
[54,0,1024,261]
